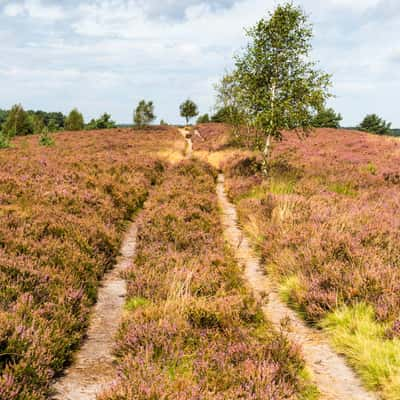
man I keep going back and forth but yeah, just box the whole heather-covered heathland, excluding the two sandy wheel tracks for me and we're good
[0,124,400,400]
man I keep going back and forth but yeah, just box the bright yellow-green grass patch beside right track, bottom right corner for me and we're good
[321,303,400,400]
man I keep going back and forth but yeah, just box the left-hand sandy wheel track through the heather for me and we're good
[53,224,137,400]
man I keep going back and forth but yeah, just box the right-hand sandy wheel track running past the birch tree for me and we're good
[217,174,377,400]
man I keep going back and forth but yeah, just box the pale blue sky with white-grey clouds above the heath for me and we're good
[0,0,400,127]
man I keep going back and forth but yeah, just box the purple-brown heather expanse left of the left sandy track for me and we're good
[0,129,178,400]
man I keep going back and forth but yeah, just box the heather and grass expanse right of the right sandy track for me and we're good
[195,124,400,399]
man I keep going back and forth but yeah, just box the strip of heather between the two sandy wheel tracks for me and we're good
[100,161,308,400]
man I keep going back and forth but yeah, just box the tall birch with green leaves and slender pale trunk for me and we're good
[232,3,330,174]
